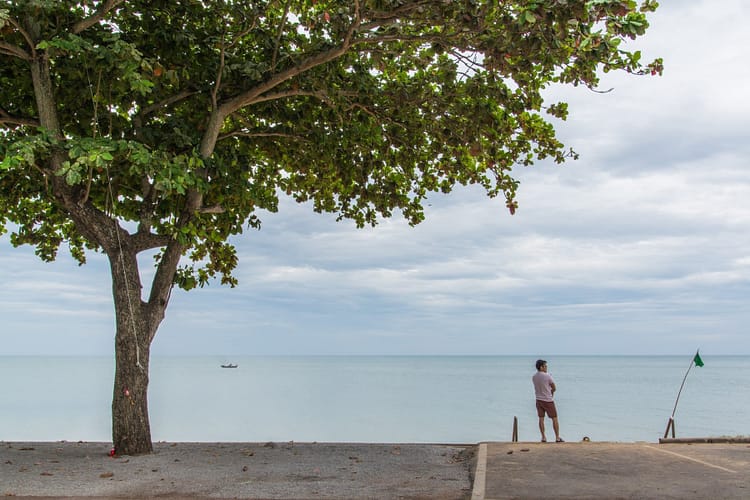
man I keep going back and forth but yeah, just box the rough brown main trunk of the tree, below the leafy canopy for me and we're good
[109,250,159,455]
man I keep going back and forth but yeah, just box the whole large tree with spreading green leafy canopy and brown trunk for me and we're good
[0,0,662,454]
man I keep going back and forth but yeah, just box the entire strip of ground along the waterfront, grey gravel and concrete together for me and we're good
[0,442,750,500]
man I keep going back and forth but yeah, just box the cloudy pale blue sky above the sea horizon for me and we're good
[0,0,750,359]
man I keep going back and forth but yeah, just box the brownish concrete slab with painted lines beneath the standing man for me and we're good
[472,442,750,500]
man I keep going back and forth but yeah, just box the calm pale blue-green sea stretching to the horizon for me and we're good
[0,355,750,443]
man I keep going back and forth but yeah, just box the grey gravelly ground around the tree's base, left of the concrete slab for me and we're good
[0,442,476,499]
